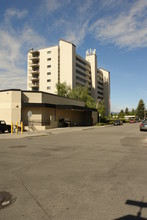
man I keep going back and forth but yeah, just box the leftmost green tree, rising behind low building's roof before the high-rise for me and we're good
[56,82,71,97]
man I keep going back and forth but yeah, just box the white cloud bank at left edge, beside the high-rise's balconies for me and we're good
[0,9,45,89]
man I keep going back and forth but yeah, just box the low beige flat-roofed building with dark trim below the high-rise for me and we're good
[0,89,97,129]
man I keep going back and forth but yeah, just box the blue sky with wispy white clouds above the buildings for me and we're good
[0,0,147,111]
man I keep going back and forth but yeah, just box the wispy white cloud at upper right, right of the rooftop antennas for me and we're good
[90,0,147,49]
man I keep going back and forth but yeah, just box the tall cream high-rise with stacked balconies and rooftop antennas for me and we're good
[27,40,110,115]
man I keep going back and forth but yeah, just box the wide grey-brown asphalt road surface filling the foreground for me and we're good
[0,124,147,220]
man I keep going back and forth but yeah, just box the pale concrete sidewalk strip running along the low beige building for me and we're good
[0,126,100,139]
